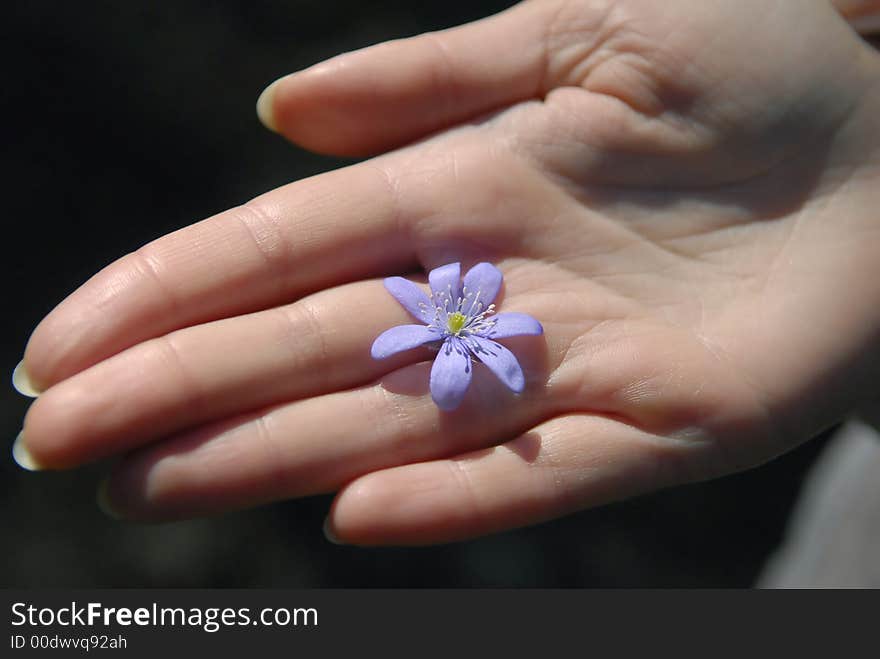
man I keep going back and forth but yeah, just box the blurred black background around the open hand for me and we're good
[0,0,827,587]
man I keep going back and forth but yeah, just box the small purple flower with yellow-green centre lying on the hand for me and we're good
[371,263,544,410]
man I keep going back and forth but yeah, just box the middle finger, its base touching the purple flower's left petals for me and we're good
[24,281,428,468]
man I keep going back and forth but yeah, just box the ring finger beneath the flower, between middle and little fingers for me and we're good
[98,346,546,519]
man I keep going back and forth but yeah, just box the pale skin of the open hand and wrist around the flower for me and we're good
[15,0,880,545]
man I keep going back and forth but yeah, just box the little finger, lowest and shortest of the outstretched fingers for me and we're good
[327,415,706,545]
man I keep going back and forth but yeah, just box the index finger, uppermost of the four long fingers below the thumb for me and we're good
[24,157,415,390]
